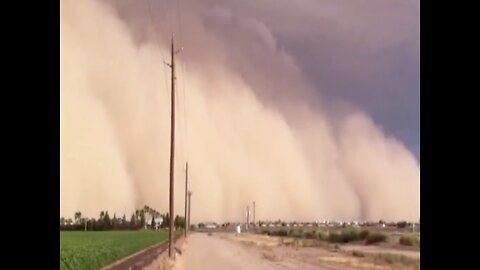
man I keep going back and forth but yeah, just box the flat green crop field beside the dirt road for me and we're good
[60,231,168,270]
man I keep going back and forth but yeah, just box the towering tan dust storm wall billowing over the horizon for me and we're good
[60,0,420,222]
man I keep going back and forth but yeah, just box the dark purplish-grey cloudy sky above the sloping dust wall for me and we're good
[204,0,420,159]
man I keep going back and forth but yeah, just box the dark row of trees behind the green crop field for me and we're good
[60,205,185,231]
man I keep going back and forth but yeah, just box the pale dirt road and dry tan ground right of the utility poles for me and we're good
[147,233,419,270]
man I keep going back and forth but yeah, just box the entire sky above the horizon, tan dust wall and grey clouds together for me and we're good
[60,0,420,222]
